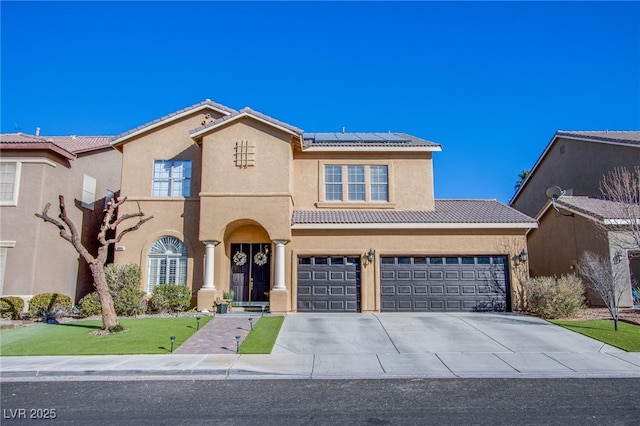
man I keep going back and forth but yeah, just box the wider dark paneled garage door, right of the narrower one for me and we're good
[380,256,509,312]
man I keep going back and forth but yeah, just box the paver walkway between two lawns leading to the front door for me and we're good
[173,313,260,355]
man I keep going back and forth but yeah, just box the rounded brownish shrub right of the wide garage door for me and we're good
[524,274,584,319]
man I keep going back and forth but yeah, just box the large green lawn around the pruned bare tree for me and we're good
[0,315,212,356]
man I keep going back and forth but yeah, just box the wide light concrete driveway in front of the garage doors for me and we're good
[272,313,620,355]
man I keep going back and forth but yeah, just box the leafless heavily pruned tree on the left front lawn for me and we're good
[36,195,153,331]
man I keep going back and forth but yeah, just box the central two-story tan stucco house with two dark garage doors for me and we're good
[112,100,537,313]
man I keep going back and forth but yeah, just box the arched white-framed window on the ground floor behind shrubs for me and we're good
[147,236,187,294]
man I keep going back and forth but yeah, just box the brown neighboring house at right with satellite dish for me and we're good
[511,131,640,306]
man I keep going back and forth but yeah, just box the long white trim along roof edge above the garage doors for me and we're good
[291,223,538,229]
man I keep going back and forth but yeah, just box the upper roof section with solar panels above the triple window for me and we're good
[303,132,440,148]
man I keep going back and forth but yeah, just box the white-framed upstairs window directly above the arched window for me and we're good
[153,160,191,197]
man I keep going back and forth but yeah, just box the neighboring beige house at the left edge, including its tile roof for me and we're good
[0,133,121,301]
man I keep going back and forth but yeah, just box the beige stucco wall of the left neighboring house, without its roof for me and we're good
[0,149,121,301]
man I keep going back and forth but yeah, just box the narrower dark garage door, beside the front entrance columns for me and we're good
[298,256,360,312]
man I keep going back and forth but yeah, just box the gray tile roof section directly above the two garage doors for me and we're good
[292,200,537,227]
